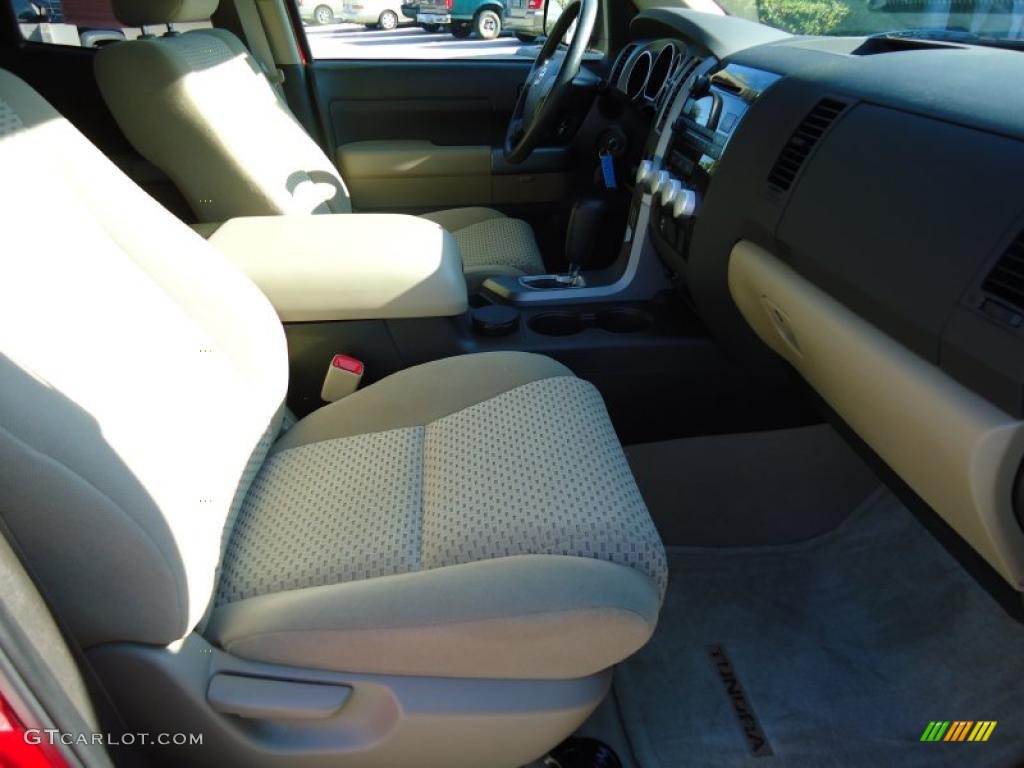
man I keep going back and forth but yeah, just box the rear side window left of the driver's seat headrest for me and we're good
[9,0,210,47]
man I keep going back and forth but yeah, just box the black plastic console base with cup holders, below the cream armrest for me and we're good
[285,294,818,443]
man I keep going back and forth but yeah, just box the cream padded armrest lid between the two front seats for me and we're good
[209,213,467,322]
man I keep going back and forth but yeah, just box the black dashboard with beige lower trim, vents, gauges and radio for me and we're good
[611,9,1024,591]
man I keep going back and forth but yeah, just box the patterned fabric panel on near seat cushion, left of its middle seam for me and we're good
[218,427,424,602]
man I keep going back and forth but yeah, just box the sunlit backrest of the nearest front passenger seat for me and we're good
[0,71,288,646]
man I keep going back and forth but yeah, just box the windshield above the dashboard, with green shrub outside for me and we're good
[655,0,1024,45]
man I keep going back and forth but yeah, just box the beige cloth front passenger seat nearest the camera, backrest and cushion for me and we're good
[0,72,666,765]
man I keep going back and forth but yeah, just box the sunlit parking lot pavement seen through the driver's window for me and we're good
[306,24,538,58]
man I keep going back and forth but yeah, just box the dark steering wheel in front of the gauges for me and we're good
[502,0,598,163]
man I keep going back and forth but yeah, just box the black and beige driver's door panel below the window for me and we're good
[311,59,569,213]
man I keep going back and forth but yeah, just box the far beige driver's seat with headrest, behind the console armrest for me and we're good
[95,0,544,284]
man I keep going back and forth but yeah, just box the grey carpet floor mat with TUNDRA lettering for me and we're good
[615,490,1024,768]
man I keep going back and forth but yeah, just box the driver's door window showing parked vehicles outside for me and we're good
[297,0,569,59]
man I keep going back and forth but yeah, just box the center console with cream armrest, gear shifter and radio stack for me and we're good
[226,52,800,442]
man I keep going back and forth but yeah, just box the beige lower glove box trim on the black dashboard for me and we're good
[729,241,1024,590]
